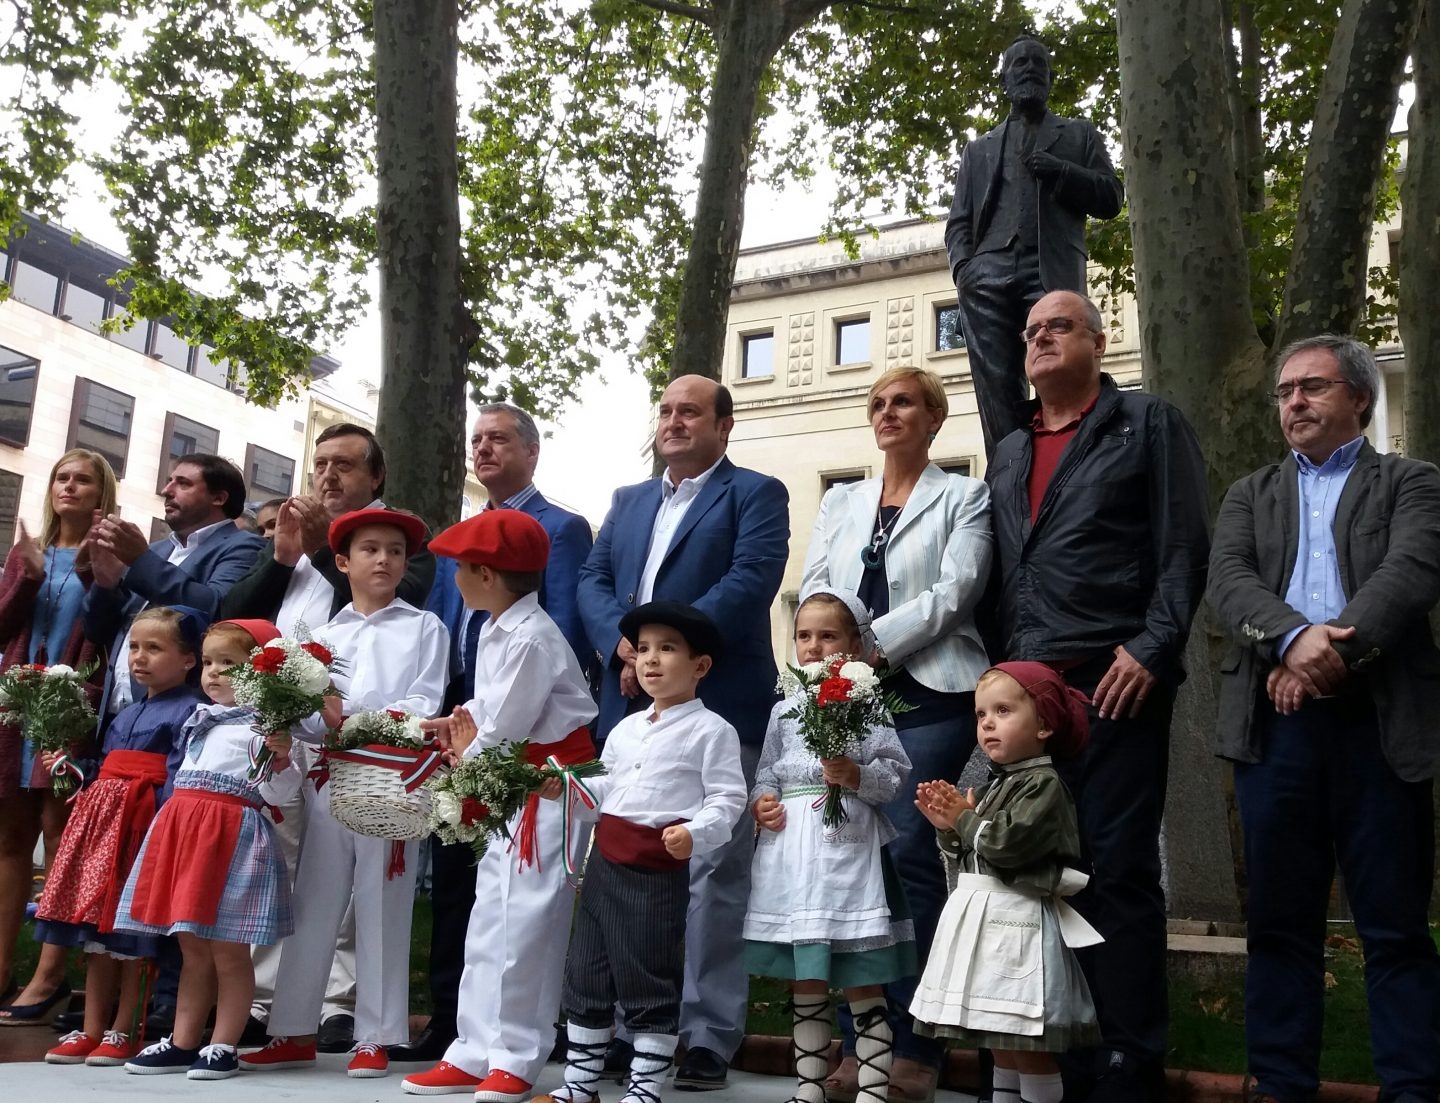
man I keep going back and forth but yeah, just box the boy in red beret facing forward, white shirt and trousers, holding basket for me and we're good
[240,510,449,1077]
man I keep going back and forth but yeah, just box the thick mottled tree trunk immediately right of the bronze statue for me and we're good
[1116,0,1274,919]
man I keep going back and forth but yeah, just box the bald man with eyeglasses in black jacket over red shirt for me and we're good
[985,291,1210,1103]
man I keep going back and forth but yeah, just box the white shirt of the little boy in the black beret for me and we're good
[582,697,747,854]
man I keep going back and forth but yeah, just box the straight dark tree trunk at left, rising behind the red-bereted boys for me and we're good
[374,0,475,531]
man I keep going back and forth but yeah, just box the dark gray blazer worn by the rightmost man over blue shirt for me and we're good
[1207,444,1440,782]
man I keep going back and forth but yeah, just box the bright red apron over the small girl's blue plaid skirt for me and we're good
[130,789,255,927]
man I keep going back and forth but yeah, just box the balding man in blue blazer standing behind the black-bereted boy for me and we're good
[579,376,791,1090]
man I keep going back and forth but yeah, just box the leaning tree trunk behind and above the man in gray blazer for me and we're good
[1276,0,1423,347]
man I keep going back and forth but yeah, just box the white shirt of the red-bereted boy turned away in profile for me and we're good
[464,593,596,759]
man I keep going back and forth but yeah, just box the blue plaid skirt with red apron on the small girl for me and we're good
[115,770,295,946]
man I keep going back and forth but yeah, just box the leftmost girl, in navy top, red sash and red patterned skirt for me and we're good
[35,606,204,1064]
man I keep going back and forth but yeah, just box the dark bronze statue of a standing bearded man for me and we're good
[945,35,1125,456]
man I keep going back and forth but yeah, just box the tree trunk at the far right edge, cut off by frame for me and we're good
[1400,0,1440,916]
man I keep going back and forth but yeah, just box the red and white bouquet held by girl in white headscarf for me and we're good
[778,655,910,828]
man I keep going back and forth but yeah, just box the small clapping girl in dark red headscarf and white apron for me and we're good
[910,662,1100,1103]
